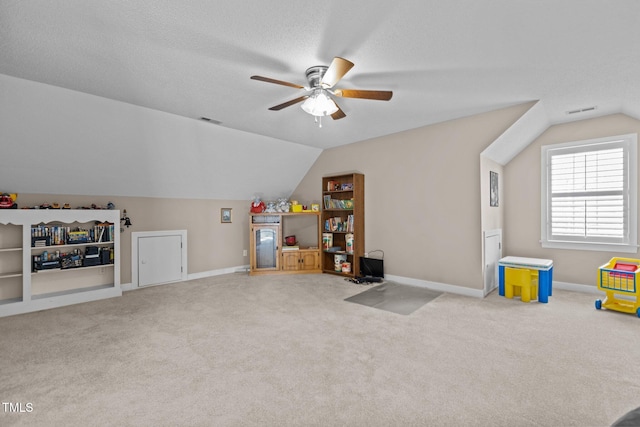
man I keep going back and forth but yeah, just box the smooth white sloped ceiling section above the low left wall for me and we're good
[0,74,322,200]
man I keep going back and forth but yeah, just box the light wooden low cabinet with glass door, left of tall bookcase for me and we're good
[249,212,321,275]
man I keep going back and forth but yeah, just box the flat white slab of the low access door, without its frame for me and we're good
[138,234,183,286]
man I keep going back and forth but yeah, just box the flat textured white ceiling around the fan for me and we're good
[0,0,640,152]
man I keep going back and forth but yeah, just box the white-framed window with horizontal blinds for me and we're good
[541,134,638,253]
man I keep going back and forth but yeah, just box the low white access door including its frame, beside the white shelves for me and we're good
[132,231,187,287]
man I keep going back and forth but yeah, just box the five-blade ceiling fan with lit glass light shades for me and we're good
[251,56,393,127]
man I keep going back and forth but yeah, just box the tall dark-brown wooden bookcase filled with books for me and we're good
[321,173,364,277]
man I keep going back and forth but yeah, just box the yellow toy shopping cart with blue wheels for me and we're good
[596,258,640,317]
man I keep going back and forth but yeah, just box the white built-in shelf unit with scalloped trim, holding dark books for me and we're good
[0,209,122,317]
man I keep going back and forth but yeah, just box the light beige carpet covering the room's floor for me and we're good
[0,273,640,426]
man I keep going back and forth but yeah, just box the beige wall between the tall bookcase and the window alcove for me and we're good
[292,104,530,289]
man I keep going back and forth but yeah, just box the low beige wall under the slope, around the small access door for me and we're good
[17,194,250,284]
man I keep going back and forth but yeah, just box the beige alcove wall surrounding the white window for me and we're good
[503,114,640,286]
